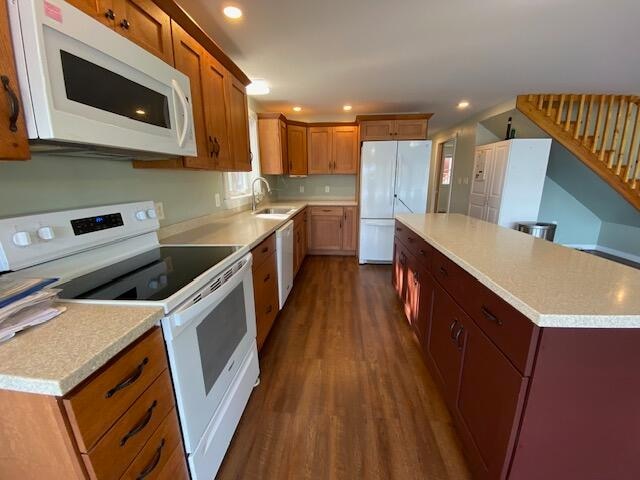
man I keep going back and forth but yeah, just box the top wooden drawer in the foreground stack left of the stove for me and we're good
[63,327,167,453]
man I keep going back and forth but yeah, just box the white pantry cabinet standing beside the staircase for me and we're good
[468,138,551,228]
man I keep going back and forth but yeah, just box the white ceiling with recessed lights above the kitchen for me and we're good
[177,0,640,129]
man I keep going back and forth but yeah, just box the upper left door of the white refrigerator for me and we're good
[360,141,398,218]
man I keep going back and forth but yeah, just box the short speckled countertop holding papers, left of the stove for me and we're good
[0,303,163,396]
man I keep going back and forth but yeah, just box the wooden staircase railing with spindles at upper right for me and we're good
[517,93,640,209]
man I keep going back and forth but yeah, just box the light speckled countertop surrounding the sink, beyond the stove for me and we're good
[162,200,357,248]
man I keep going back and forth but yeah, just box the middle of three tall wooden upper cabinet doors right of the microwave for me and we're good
[202,52,234,170]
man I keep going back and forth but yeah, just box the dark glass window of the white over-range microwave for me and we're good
[60,50,171,129]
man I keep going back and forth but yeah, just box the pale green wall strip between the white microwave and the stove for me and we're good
[0,156,229,225]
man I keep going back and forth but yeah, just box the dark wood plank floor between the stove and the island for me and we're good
[217,257,470,480]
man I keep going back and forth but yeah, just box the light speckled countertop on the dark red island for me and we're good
[397,214,640,328]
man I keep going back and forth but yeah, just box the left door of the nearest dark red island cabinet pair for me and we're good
[428,285,471,410]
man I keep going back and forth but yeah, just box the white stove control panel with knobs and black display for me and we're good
[0,201,160,272]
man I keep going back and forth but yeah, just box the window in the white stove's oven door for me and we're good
[196,283,247,395]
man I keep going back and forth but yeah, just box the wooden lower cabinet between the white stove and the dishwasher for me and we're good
[251,234,279,350]
